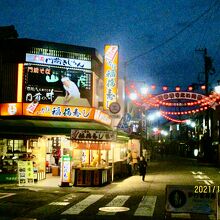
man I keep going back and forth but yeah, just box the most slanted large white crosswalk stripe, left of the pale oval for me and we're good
[61,195,104,215]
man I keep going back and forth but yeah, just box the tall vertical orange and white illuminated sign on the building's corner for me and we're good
[103,45,118,110]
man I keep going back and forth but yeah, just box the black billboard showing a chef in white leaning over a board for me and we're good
[23,64,92,106]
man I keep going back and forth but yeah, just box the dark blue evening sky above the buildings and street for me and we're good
[0,0,220,90]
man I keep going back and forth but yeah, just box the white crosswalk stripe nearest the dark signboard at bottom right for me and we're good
[134,196,157,216]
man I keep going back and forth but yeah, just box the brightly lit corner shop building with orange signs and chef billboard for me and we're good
[0,39,129,186]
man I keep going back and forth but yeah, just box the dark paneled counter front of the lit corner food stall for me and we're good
[72,166,112,186]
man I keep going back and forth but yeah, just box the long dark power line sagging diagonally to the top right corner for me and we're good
[125,0,218,64]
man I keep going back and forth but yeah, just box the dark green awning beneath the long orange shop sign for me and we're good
[0,119,112,136]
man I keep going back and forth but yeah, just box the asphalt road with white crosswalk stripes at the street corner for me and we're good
[0,156,220,220]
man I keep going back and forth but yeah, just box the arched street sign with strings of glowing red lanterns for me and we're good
[126,84,220,123]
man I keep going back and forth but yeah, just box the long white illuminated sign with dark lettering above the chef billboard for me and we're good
[26,53,91,69]
